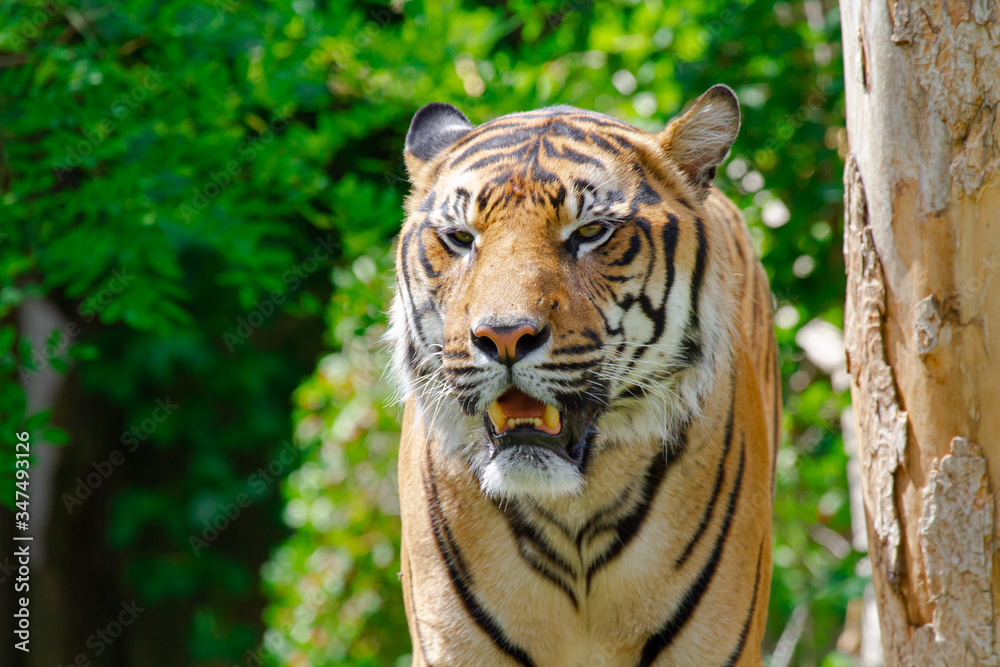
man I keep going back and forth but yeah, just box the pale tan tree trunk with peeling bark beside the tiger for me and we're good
[840,0,1000,667]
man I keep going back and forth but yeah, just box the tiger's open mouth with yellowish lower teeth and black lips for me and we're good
[483,387,596,466]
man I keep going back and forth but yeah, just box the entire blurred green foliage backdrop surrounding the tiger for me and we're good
[0,0,864,667]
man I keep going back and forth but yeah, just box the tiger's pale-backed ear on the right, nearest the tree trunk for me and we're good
[659,83,740,188]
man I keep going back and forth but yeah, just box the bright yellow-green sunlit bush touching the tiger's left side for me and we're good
[264,249,409,665]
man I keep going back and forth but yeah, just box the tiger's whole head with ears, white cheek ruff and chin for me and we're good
[390,85,740,498]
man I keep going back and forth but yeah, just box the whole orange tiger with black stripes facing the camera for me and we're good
[387,85,781,667]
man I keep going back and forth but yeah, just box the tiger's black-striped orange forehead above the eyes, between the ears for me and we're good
[418,107,684,224]
